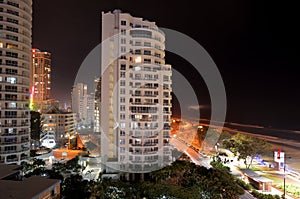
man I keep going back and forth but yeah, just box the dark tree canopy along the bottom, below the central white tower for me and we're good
[22,158,243,199]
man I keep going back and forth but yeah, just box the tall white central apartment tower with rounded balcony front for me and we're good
[100,10,172,178]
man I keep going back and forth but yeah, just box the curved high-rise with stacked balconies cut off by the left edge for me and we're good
[0,0,32,164]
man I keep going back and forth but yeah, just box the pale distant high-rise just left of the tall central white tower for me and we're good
[72,83,95,127]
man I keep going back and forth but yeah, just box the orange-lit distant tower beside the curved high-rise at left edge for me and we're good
[31,49,51,105]
